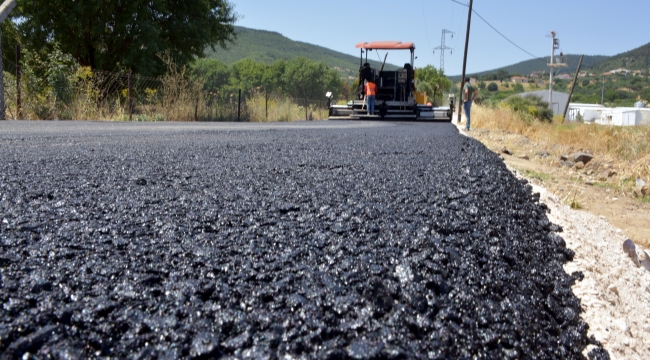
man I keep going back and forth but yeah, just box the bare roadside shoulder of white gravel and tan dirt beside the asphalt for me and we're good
[463,123,650,359]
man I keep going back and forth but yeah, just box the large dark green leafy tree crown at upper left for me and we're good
[12,0,237,75]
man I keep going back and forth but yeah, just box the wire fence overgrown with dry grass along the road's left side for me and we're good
[3,47,327,121]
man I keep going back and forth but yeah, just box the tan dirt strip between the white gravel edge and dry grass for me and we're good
[466,129,650,248]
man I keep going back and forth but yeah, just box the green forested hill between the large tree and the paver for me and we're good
[206,26,397,78]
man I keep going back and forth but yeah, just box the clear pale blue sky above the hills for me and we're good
[230,0,650,75]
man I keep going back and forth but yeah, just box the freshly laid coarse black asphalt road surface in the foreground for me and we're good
[0,122,609,359]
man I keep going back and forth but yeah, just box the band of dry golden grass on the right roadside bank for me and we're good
[472,106,650,182]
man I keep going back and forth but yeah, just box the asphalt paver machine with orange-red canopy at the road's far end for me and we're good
[327,41,454,122]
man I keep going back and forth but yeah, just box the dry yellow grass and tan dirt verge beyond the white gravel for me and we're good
[461,106,650,245]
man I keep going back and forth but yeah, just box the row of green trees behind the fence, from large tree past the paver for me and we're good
[2,0,451,114]
